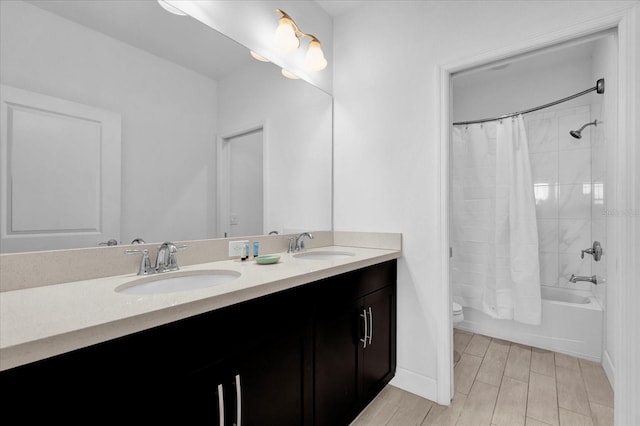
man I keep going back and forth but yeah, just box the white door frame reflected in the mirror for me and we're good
[215,120,270,238]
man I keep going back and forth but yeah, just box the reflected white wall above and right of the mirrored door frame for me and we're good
[218,61,332,233]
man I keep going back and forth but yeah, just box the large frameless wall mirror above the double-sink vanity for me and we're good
[0,0,333,253]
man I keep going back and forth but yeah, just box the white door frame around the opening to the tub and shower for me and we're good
[436,5,640,424]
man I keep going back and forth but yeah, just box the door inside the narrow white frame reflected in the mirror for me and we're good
[225,128,264,237]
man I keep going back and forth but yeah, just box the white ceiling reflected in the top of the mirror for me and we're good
[27,0,253,80]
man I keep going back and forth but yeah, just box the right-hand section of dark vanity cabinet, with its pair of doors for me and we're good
[314,262,396,425]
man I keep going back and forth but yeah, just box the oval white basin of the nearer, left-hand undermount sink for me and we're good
[116,270,241,294]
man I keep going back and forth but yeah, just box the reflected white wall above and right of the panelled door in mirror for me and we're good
[0,1,216,243]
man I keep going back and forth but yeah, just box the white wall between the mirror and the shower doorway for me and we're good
[334,1,631,403]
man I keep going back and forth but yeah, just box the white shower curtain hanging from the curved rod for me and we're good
[451,116,542,324]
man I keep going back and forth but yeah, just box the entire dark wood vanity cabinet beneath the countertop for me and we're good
[0,260,396,426]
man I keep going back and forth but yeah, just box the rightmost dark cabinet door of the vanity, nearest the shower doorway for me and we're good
[360,286,396,402]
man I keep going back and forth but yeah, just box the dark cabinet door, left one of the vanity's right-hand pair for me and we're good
[315,296,360,426]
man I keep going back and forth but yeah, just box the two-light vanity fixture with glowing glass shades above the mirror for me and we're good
[274,9,327,71]
